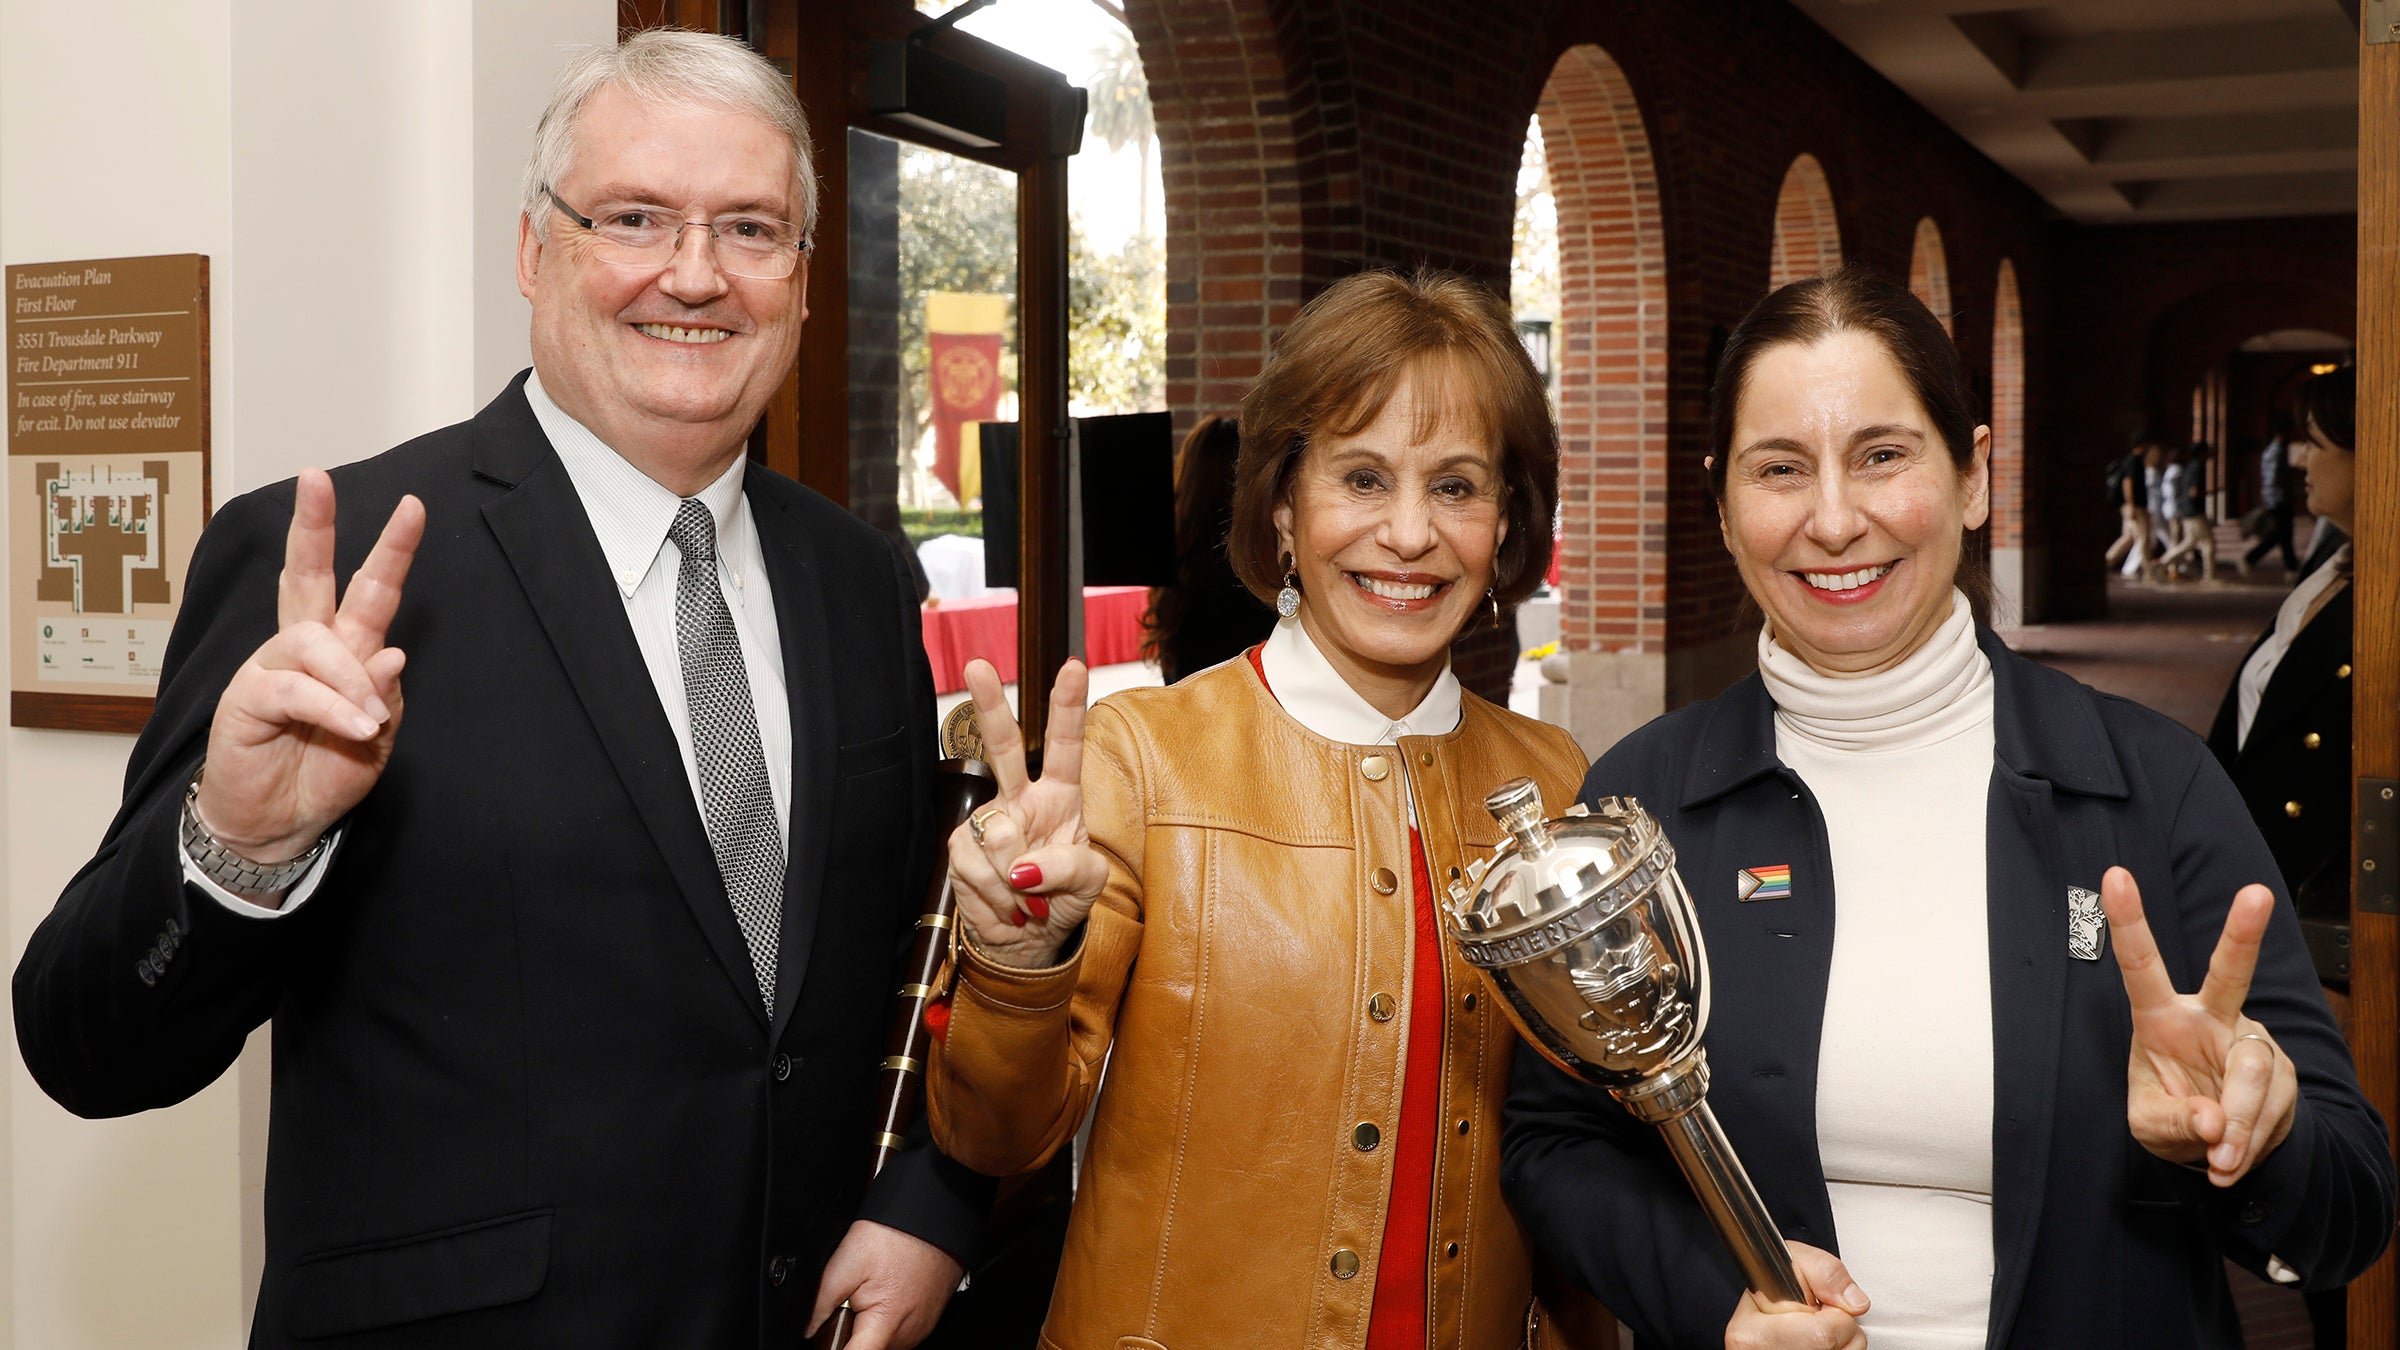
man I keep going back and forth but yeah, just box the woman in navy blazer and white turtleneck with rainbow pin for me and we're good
[1502,269,2395,1350]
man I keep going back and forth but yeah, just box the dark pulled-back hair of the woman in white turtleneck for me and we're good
[1709,262,1992,617]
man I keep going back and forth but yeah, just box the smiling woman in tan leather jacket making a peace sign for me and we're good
[929,274,1584,1350]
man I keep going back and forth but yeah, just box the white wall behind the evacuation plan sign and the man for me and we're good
[0,0,614,1350]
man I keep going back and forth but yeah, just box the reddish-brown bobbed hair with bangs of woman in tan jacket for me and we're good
[1226,269,1558,605]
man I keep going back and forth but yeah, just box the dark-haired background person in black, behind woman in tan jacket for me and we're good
[1142,416,1274,685]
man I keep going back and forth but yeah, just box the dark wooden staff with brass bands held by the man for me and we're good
[811,699,1001,1350]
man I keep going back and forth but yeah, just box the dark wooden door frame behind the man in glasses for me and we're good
[617,0,1082,747]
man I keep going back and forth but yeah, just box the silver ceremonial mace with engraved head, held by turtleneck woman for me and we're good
[1450,778,1814,1304]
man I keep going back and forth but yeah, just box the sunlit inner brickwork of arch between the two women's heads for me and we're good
[1536,43,1668,742]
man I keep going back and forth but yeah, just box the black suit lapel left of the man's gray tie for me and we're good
[475,394,766,1021]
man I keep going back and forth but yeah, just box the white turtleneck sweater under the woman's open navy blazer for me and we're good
[1759,591,1992,1350]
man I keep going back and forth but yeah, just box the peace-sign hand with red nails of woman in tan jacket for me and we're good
[950,661,1109,970]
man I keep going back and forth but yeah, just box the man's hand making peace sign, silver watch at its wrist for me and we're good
[194,468,425,893]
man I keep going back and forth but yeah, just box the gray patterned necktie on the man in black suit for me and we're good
[667,500,782,1009]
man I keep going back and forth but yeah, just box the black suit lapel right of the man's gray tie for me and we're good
[744,478,840,1038]
